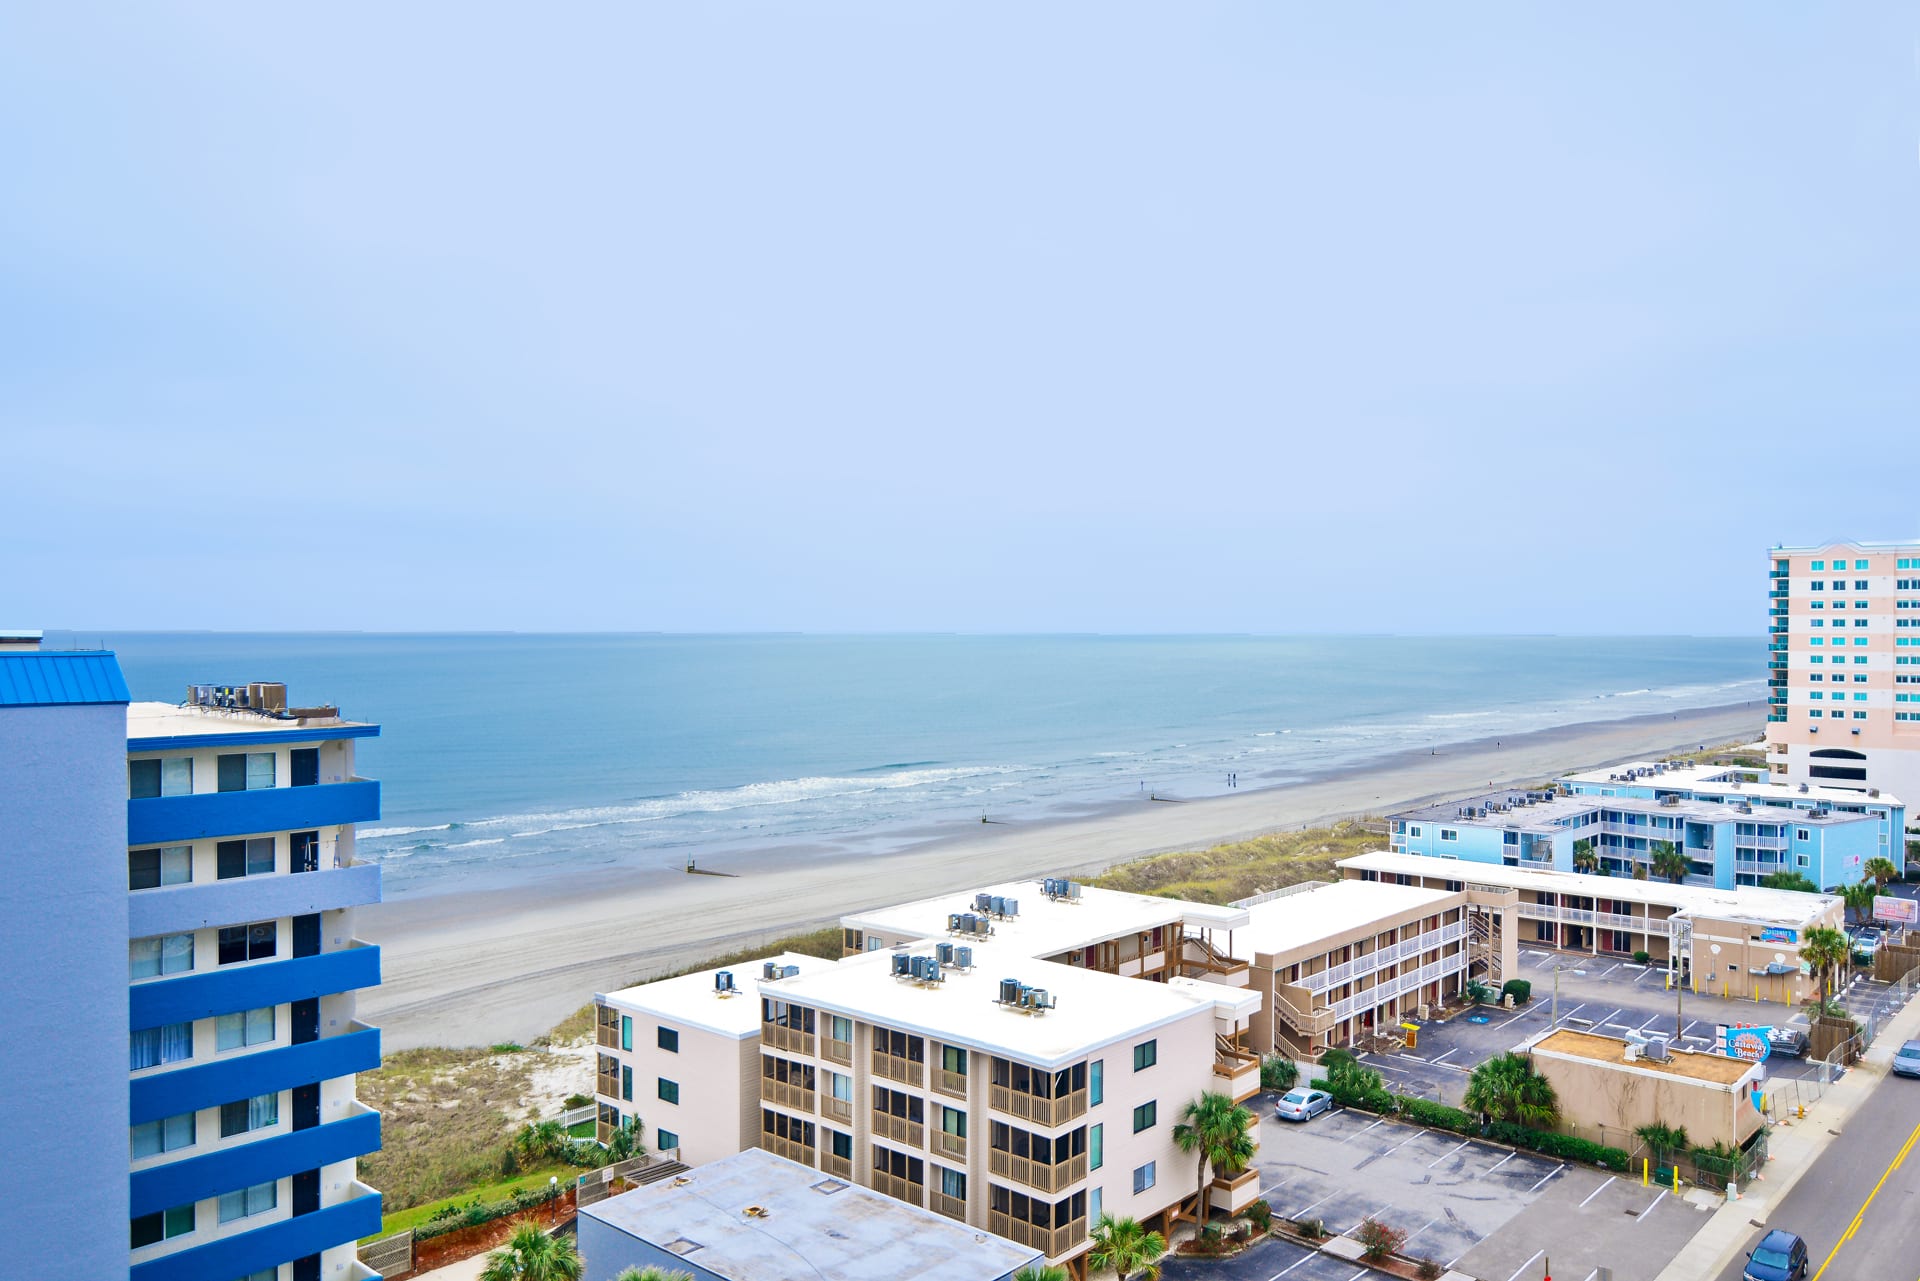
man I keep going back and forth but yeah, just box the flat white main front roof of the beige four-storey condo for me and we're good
[775,933,1217,1068]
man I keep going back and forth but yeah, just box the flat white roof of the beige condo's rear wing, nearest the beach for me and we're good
[841,880,1246,956]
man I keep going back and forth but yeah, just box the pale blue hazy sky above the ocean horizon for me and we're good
[0,2,1920,634]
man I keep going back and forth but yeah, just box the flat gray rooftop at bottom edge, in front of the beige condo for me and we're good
[580,1148,1041,1281]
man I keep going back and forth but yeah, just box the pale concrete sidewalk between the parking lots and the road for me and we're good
[1659,1001,1920,1281]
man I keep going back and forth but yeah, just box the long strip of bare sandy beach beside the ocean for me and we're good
[359,703,1766,1051]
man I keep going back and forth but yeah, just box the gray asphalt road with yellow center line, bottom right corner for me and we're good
[1720,1074,1920,1281]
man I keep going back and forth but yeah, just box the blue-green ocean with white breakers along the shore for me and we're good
[63,634,1764,897]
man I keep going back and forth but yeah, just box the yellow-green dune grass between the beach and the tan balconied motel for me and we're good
[1087,820,1384,903]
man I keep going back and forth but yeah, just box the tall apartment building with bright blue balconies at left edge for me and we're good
[0,651,380,1281]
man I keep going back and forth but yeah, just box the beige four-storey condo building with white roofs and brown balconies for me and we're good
[597,880,1261,1275]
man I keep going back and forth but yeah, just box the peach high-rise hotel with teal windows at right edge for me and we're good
[1766,540,1920,833]
